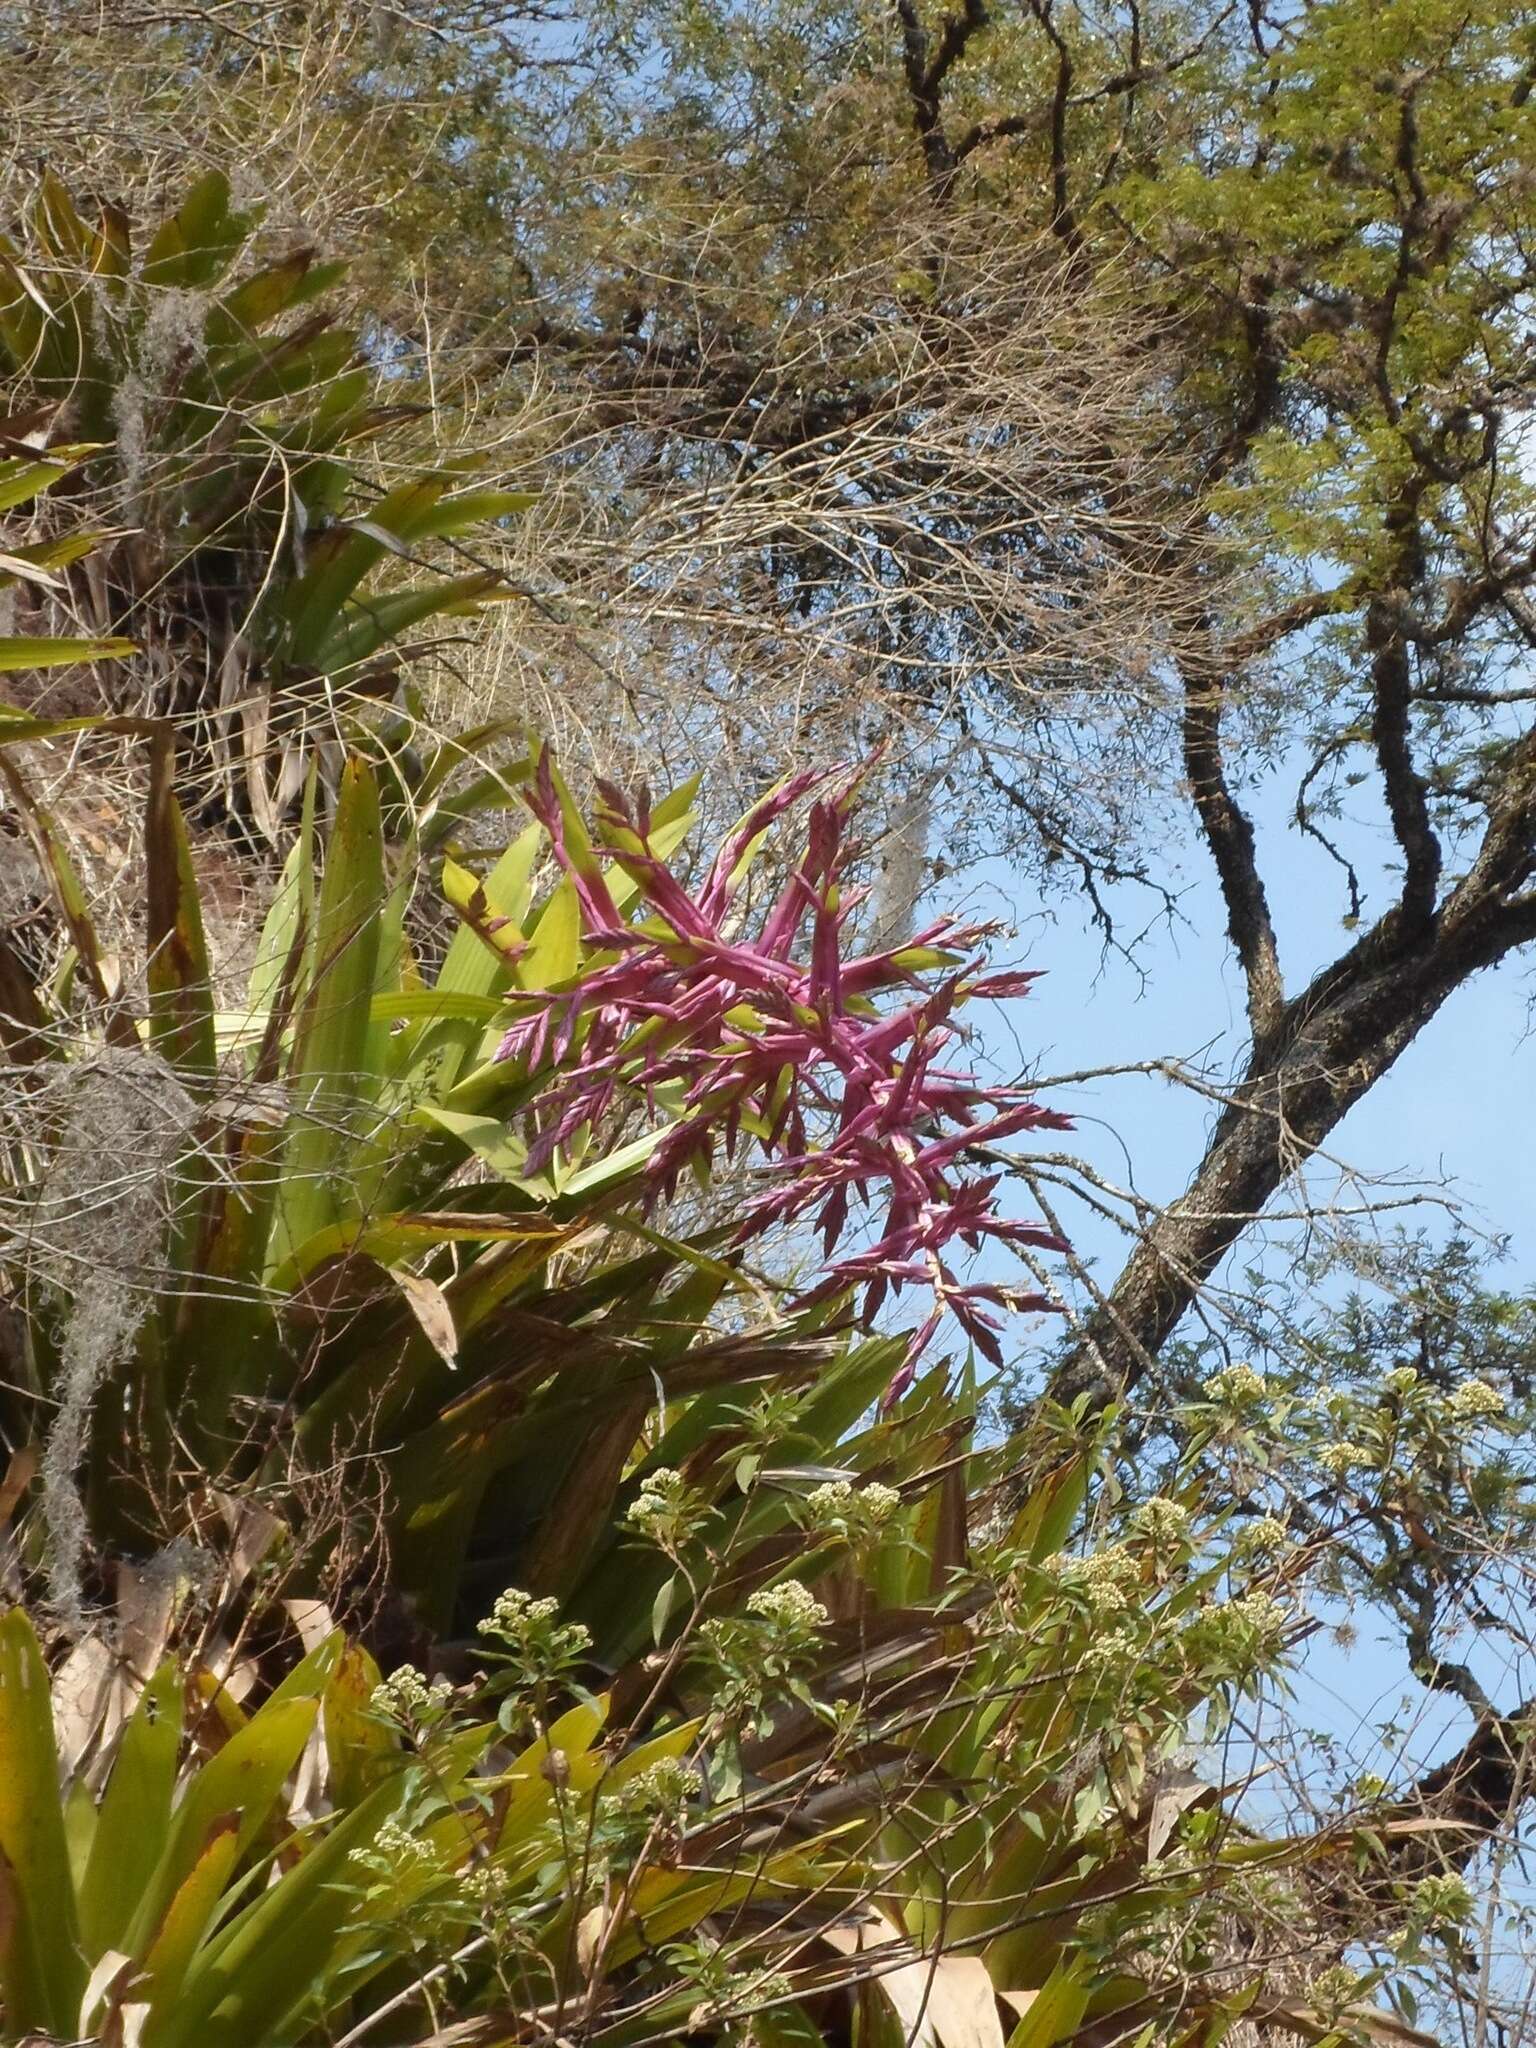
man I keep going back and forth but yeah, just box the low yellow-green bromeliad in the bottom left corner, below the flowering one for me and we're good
[0,1599,856,2048]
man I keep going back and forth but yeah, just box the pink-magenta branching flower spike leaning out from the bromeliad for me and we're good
[500,754,1071,1395]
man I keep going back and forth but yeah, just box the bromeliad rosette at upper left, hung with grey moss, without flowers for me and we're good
[0,172,530,838]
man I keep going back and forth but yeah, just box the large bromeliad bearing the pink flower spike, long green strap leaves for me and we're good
[4,719,1073,1632]
